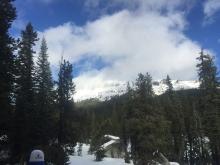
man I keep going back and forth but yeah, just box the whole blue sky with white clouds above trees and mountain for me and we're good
[11,0,220,99]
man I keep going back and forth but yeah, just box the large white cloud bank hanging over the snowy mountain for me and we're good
[37,0,200,99]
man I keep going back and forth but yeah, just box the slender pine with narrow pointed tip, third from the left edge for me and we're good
[34,38,55,145]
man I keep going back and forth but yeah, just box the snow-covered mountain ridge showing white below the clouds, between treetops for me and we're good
[74,80,199,101]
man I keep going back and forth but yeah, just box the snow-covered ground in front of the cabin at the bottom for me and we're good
[70,144,132,165]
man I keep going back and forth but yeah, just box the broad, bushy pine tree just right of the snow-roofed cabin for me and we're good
[129,73,167,165]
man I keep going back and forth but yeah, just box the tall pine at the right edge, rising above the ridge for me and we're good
[197,50,220,164]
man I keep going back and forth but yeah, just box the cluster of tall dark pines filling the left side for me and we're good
[0,0,78,164]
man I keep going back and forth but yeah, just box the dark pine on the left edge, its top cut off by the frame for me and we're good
[0,0,16,164]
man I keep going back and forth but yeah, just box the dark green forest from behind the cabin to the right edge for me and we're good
[80,51,220,165]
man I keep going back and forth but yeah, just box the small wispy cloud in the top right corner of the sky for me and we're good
[203,0,220,23]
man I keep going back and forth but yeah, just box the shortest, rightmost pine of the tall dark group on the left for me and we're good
[52,59,79,164]
